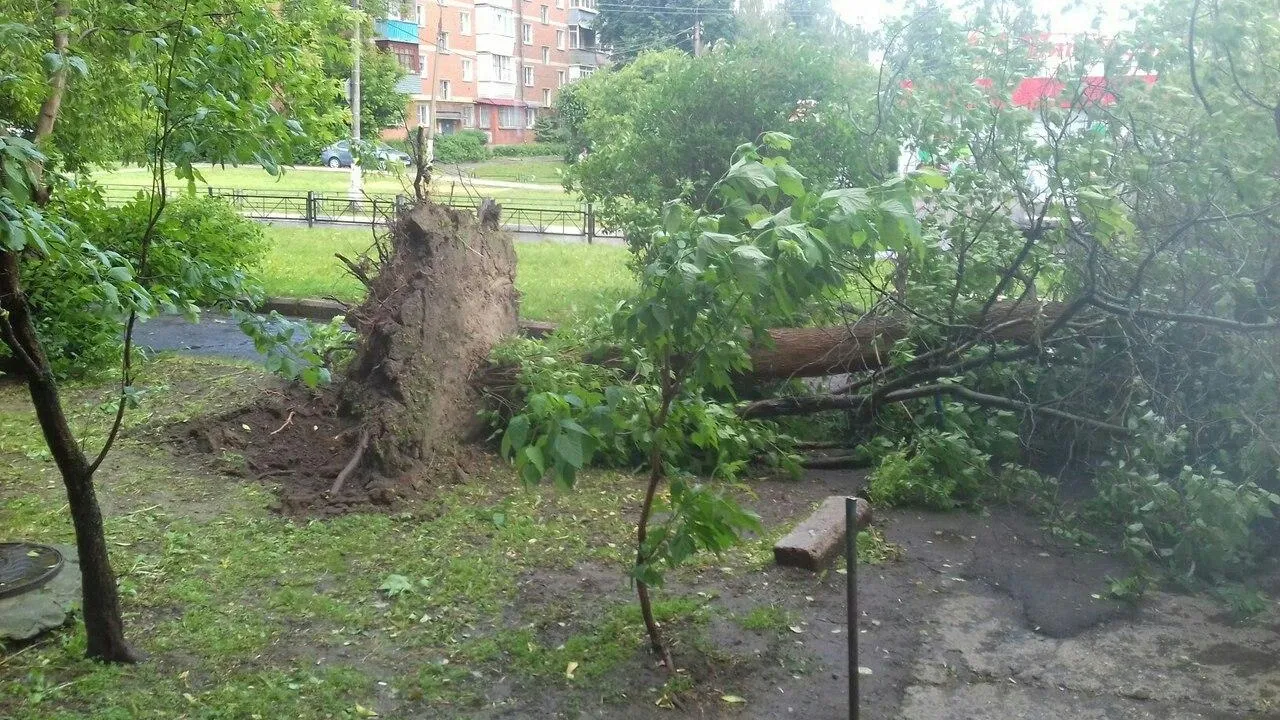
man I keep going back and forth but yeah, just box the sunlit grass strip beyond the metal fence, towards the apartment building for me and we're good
[93,159,575,205]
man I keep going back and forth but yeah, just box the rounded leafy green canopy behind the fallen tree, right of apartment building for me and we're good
[557,29,892,233]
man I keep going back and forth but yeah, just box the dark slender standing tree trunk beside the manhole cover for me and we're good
[0,252,140,662]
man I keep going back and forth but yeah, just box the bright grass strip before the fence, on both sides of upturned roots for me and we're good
[260,225,634,323]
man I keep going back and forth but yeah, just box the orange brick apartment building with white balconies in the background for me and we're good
[375,0,607,145]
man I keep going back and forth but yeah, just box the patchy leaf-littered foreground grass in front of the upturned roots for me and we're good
[0,356,885,720]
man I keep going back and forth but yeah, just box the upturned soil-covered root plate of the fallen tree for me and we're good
[335,202,517,489]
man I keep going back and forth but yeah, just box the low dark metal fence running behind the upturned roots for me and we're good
[101,184,596,242]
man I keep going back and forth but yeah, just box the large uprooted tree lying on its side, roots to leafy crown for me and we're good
[247,3,1280,669]
